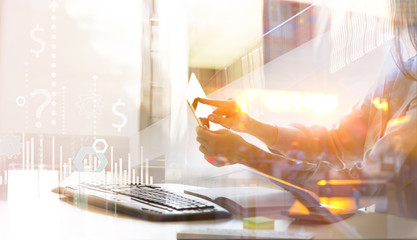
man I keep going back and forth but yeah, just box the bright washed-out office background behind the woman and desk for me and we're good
[0,0,413,238]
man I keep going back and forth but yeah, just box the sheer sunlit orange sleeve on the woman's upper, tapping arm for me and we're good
[269,91,372,172]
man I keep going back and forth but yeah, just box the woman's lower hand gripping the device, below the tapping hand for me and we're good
[196,127,252,167]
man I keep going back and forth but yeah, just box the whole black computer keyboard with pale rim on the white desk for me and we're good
[53,183,231,221]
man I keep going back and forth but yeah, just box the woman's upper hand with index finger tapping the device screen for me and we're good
[193,98,253,132]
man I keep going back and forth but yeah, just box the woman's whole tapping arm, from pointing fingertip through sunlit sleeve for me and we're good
[197,96,371,167]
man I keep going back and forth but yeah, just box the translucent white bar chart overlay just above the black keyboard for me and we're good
[0,132,154,185]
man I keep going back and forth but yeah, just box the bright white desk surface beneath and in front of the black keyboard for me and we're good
[0,170,417,239]
